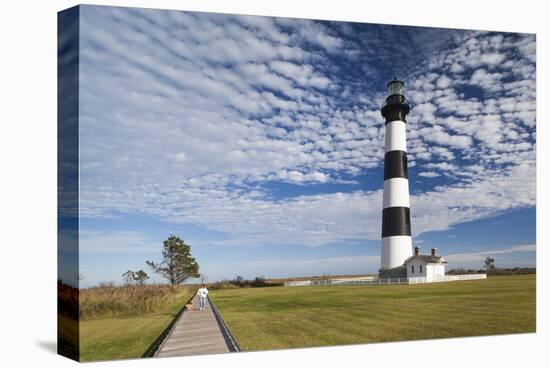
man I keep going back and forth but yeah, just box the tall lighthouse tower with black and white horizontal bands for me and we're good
[379,79,412,278]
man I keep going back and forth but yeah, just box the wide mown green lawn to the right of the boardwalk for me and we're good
[210,275,536,351]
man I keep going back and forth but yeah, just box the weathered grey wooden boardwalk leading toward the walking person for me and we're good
[155,295,234,357]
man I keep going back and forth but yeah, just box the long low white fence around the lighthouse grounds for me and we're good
[285,274,487,287]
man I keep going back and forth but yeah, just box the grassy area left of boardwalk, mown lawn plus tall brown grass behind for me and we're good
[80,286,196,361]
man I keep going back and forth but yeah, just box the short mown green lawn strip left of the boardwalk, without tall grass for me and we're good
[80,289,194,361]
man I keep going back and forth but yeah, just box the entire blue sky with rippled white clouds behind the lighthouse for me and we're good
[71,6,536,286]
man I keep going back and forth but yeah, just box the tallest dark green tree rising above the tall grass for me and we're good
[146,235,200,284]
